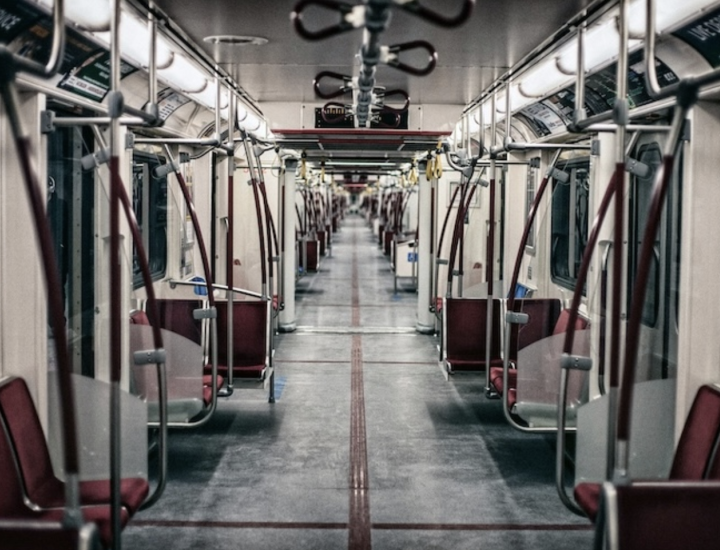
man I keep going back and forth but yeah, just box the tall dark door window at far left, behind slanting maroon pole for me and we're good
[47,127,95,377]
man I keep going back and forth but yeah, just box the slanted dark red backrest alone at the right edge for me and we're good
[670,385,720,480]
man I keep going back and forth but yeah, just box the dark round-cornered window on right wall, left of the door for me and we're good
[551,158,590,290]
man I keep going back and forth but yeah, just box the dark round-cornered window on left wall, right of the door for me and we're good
[133,151,168,288]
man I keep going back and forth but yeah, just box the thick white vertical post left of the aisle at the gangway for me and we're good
[279,159,298,332]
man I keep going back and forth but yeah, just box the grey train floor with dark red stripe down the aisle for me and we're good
[123,216,593,550]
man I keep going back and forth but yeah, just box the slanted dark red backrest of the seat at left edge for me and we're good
[0,377,61,512]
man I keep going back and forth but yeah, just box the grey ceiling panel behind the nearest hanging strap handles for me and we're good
[149,0,590,111]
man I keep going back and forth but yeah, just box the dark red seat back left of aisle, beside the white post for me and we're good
[210,301,268,378]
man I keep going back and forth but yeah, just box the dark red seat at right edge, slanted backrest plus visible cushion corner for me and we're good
[575,386,720,520]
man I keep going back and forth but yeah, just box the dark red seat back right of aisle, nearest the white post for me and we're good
[444,298,503,370]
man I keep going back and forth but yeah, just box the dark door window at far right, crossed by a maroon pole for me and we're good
[628,143,662,327]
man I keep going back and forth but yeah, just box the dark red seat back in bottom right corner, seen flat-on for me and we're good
[615,482,720,550]
